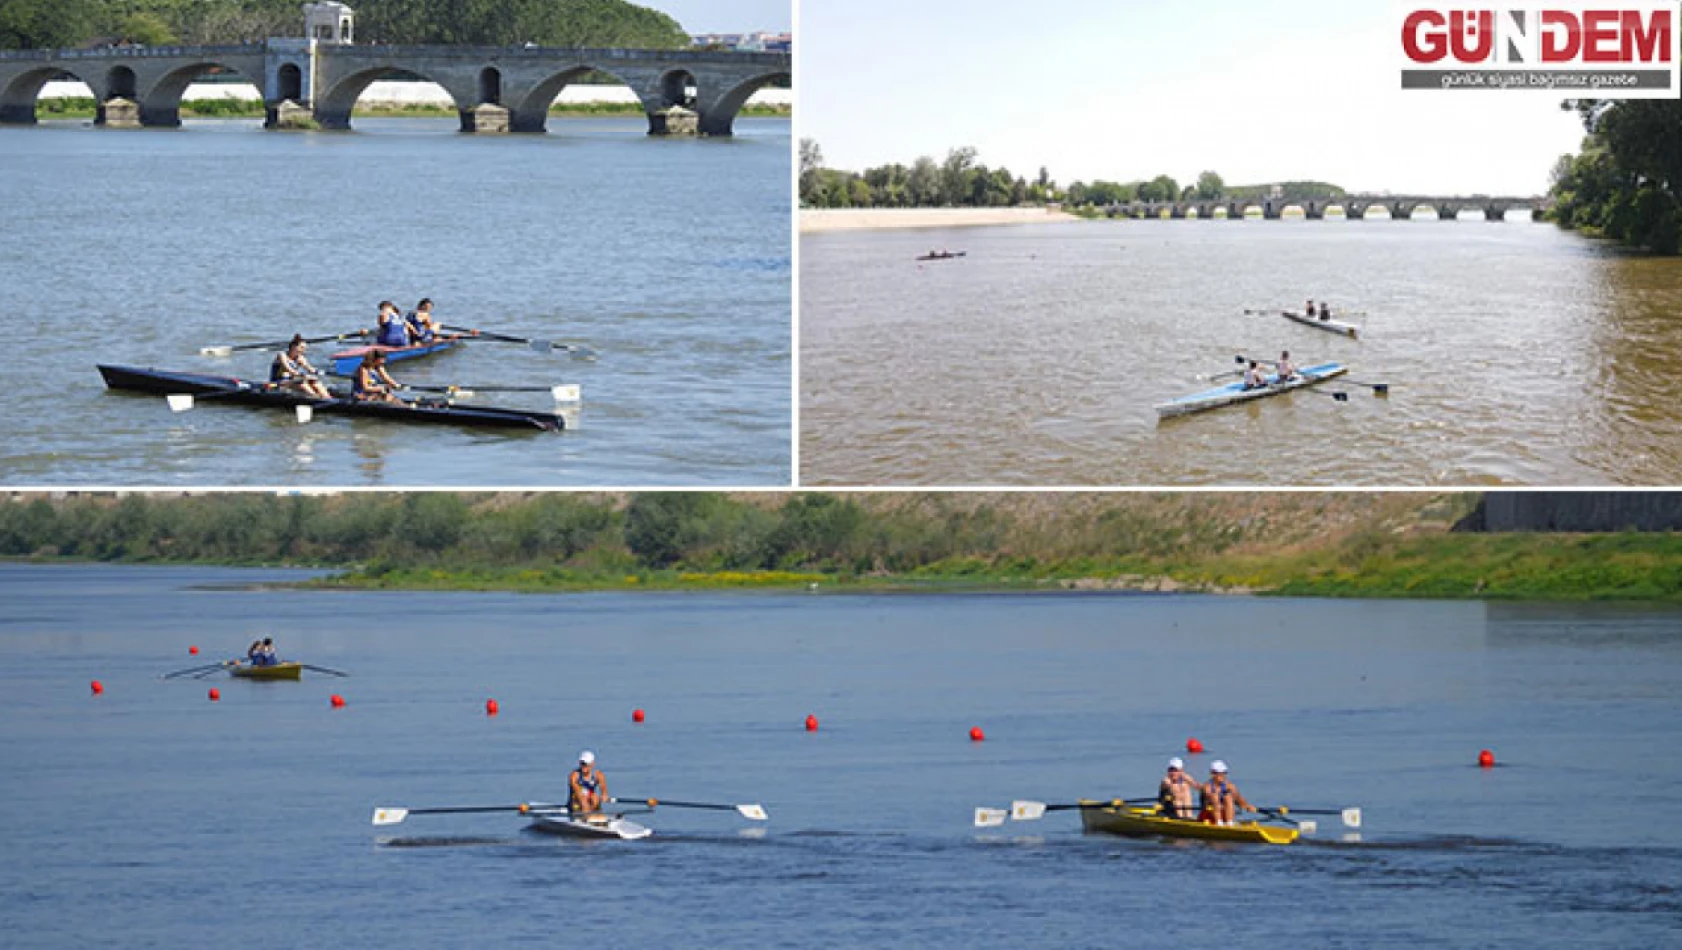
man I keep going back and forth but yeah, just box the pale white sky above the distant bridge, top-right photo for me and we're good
[794,0,1583,195]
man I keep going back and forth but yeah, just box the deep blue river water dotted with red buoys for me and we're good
[0,565,1682,948]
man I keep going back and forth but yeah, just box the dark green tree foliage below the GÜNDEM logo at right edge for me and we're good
[1549,99,1682,254]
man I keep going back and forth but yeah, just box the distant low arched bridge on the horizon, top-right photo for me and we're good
[1105,195,1552,220]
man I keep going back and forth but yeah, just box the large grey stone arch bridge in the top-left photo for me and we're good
[0,39,792,136]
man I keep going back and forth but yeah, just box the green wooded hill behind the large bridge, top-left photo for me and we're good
[0,0,690,49]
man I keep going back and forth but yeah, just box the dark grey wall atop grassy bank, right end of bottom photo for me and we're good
[1457,491,1682,531]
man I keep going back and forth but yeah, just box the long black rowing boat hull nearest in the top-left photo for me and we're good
[99,363,567,432]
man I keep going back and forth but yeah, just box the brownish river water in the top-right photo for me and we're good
[801,220,1682,486]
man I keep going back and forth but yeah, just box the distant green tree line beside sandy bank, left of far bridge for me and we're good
[801,138,1344,208]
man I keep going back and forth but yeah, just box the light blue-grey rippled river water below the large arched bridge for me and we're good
[0,118,792,488]
